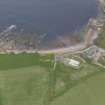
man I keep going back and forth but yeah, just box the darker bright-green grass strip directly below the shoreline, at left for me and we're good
[0,53,52,70]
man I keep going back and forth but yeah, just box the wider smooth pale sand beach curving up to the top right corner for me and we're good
[37,0,105,54]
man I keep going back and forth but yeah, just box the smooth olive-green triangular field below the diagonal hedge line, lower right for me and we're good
[51,72,105,105]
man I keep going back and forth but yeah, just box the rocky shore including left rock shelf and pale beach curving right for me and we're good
[0,0,105,54]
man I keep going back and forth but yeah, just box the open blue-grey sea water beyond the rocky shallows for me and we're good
[0,0,97,35]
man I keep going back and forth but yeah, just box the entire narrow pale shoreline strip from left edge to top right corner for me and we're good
[0,0,105,54]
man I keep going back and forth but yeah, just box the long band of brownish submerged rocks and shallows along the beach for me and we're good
[0,32,81,50]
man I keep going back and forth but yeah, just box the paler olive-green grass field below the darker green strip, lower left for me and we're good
[0,67,48,105]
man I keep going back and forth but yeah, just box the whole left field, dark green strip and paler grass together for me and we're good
[0,54,52,105]
